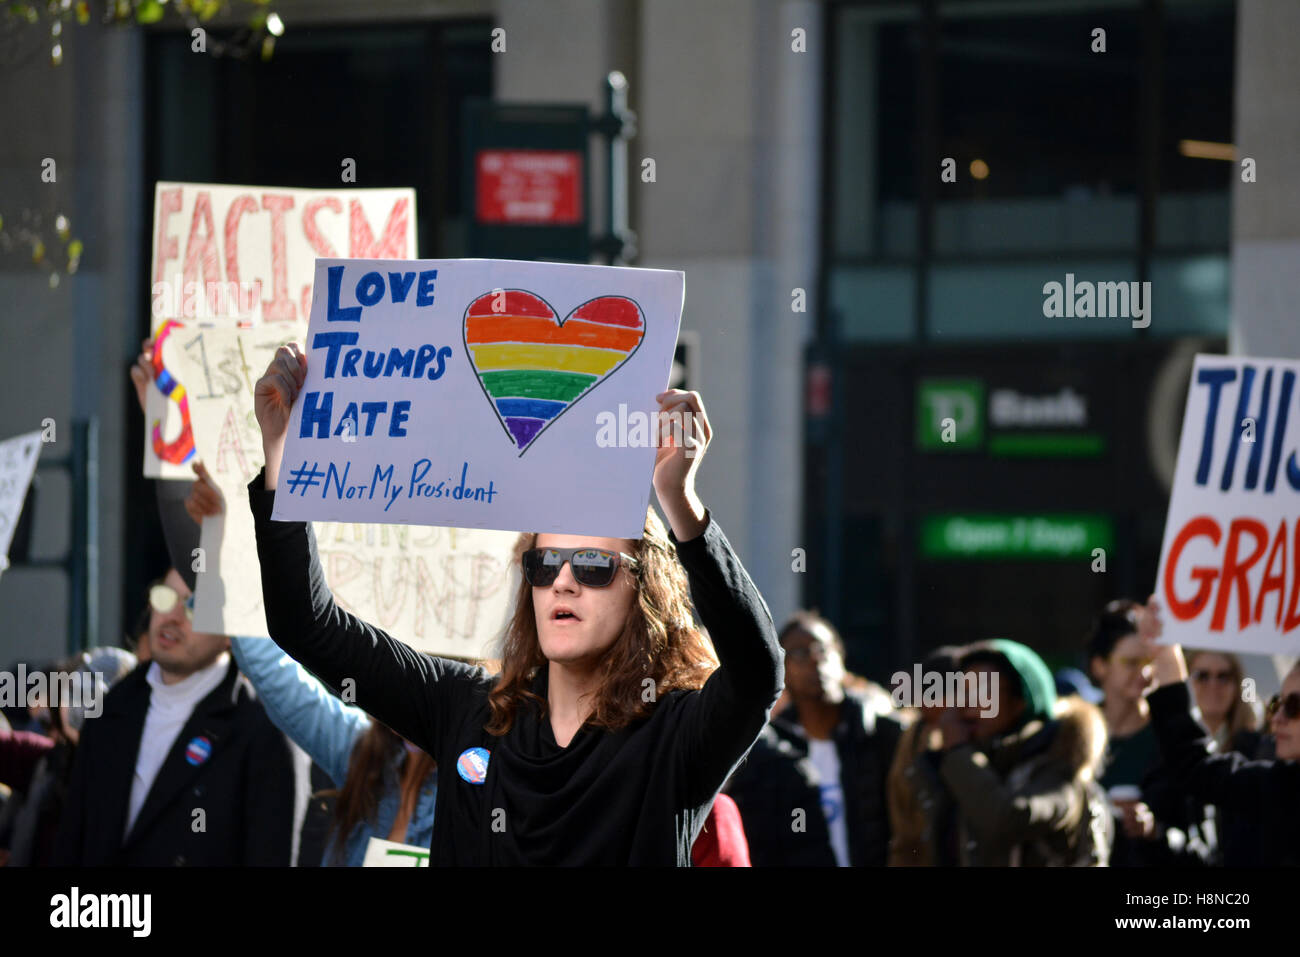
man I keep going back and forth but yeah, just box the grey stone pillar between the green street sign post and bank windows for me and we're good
[633,0,823,618]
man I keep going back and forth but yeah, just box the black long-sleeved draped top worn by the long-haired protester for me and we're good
[248,473,784,866]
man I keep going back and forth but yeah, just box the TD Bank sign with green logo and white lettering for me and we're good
[917,378,1105,458]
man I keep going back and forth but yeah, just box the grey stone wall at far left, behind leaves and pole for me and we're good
[0,25,143,666]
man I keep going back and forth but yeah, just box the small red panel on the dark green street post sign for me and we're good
[475,150,582,226]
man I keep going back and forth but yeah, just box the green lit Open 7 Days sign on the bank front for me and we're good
[920,514,1114,560]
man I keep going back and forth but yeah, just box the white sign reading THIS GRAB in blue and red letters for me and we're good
[1156,355,1300,654]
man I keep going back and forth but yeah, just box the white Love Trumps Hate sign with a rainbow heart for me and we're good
[274,259,685,538]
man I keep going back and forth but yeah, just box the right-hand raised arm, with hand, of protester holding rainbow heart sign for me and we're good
[654,389,785,801]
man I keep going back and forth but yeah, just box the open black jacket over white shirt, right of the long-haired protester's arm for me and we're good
[727,692,902,867]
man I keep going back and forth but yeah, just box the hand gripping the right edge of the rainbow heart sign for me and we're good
[654,389,714,541]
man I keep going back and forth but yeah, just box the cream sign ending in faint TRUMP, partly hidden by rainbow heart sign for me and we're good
[174,322,519,658]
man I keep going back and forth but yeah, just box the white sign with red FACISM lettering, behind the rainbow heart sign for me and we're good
[144,182,416,479]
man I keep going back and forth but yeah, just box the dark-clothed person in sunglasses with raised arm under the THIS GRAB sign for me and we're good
[1143,601,1300,867]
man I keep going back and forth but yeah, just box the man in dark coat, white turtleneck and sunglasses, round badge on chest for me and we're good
[55,571,306,867]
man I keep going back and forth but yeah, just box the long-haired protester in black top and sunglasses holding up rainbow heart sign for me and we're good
[248,346,784,866]
